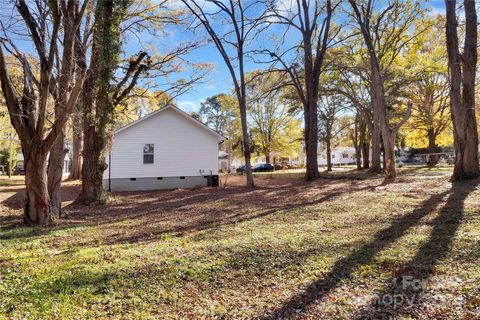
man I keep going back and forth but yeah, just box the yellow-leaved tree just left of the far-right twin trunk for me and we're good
[403,16,453,165]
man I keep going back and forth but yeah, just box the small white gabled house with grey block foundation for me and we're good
[103,105,225,191]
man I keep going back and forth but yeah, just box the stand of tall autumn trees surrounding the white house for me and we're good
[0,0,480,224]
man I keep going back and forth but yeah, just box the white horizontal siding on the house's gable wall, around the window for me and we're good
[104,108,219,179]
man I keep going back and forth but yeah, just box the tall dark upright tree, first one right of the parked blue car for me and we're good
[259,0,341,181]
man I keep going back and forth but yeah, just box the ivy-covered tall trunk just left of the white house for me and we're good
[77,0,130,204]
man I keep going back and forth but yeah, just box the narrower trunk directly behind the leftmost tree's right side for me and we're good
[48,129,68,217]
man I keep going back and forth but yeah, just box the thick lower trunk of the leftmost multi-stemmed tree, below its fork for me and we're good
[22,147,57,226]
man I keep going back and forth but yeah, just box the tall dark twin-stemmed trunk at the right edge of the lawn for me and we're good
[445,0,480,180]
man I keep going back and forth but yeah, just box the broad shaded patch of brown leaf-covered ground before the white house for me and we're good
[0,180,375,246]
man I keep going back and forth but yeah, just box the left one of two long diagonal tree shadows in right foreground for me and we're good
[262,186,449,319]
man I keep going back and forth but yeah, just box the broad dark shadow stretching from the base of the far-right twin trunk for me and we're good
[355,181,479,319]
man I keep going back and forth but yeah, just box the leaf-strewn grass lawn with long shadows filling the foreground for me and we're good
[0,167,480,319]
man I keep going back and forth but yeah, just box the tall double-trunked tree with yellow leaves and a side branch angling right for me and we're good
[349,0,422,179]
